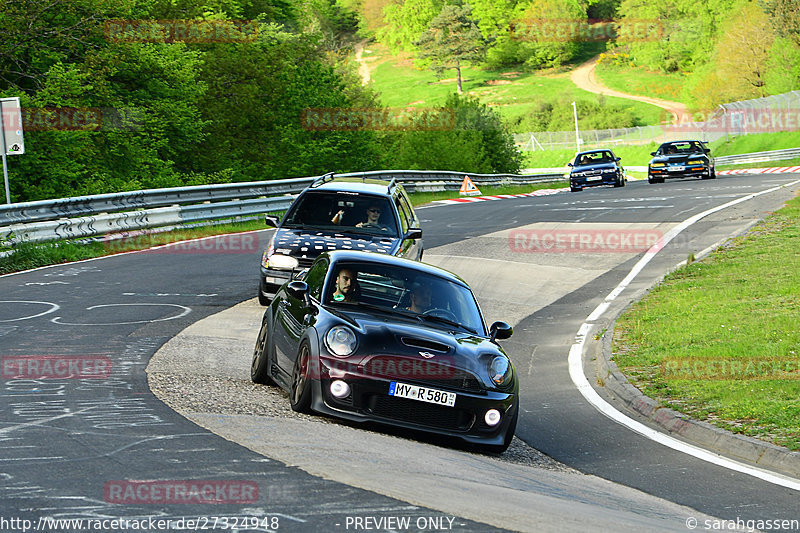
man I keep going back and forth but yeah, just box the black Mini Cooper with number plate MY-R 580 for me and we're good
[250,251,519,453]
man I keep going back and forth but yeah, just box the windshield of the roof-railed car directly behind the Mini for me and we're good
[283,191,397,237]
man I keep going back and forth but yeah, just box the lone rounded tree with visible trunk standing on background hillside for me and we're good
[414,4,486,94]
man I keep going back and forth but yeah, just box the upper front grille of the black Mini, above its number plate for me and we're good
[364,355,483,392]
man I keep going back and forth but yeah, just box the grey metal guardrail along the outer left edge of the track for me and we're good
[0,170,563,244]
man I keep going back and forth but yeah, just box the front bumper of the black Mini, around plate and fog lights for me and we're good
[311,359,516,445]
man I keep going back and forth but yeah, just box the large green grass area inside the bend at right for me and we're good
[613,193,800,450]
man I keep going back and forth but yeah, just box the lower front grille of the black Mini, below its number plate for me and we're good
[367,395,474,431]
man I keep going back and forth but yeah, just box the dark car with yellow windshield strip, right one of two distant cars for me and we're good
[647,141,717,183]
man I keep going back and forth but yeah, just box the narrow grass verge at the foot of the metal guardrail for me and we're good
[0,181,567,275]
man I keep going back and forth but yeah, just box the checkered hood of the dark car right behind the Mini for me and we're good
[273,228,400,260]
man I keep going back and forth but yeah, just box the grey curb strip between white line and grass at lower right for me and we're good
[584,306,800,478]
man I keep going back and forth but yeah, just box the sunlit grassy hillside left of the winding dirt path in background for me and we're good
[365,44,663,131]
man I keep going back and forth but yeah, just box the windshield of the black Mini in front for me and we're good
[325,262,486,336]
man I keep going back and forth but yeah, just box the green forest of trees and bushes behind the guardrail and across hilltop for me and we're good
[0,0,800,202]
